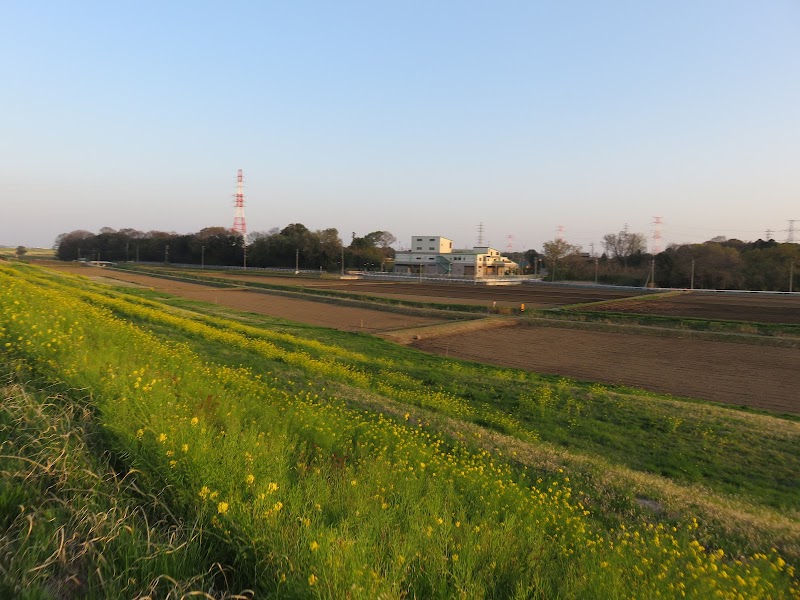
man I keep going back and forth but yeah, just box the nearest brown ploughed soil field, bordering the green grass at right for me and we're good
[412,325,800,414]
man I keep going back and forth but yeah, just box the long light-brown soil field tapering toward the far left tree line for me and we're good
[49,265,442,333]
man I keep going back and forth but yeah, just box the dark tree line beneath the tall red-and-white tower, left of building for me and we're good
[54,223,396,271]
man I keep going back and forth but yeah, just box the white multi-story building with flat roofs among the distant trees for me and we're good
[394,235,517,278]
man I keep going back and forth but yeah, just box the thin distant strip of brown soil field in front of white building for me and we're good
[166,270,648,308]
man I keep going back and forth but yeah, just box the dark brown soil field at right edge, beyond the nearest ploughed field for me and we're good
[582,292,800,325]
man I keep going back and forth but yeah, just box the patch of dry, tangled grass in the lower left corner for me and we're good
[0,362,241,600]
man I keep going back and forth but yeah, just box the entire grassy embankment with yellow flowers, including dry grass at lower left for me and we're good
[0,263,800,598]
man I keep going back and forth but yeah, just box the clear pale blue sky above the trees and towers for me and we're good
[0,0,800,251]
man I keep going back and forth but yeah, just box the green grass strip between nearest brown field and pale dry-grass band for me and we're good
[119,291,800,510]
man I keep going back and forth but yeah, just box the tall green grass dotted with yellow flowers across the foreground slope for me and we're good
[0,267,798,598]
